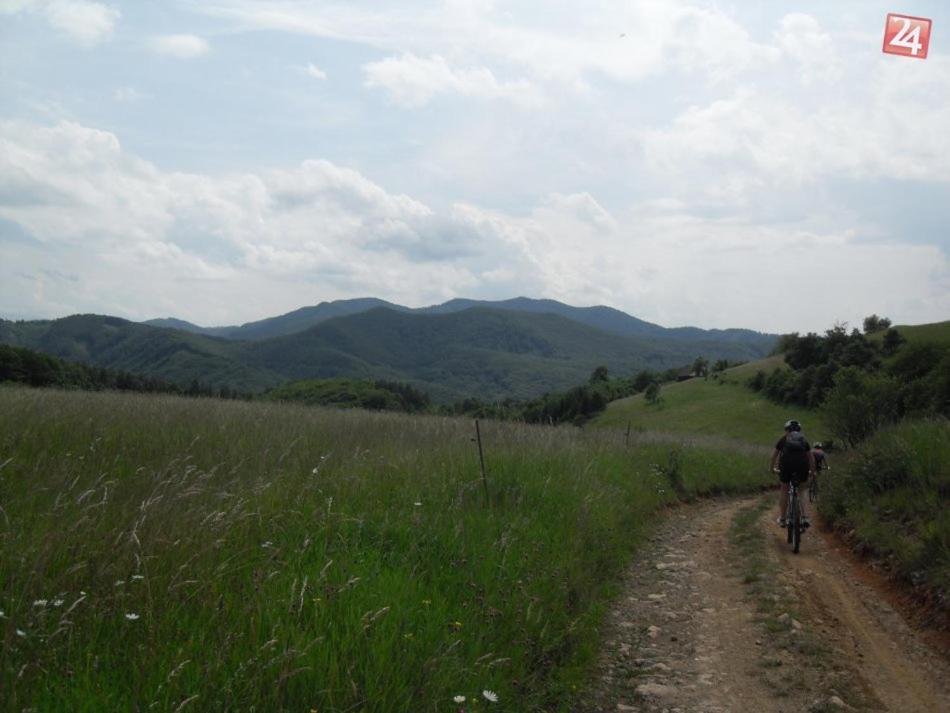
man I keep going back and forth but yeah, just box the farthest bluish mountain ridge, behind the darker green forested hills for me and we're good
[145,297,776,350]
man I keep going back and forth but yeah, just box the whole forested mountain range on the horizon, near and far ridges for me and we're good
[0,297,775,401]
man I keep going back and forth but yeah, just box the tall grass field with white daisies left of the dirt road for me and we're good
[0,388,771,713]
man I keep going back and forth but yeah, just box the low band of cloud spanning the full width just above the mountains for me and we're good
[0,117,950,331]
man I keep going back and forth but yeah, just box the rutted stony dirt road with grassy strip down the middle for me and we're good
[577,497,950,713]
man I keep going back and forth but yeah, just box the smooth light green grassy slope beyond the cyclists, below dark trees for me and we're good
[590,356,828,445]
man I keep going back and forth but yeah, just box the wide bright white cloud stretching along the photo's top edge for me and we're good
[202,0,778,89]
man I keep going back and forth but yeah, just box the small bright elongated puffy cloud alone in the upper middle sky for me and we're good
[363,54,538,107]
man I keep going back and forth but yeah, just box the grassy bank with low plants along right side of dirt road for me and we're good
[818,419,950,596]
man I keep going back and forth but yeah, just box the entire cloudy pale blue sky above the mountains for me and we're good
[0,0,950,332]
